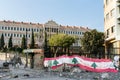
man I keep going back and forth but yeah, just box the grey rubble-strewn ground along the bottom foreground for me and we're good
[0,68,120,80]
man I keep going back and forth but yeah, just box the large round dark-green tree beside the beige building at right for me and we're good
[81,29,104,55]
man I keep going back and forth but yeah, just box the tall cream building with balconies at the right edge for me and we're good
[104,0,120,55]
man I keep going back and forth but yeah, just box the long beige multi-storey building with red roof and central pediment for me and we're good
[0,20,90,46]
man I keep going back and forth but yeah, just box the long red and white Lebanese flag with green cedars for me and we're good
[44,55,118,72]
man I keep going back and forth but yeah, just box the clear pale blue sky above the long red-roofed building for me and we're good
[0,0,104,31]
